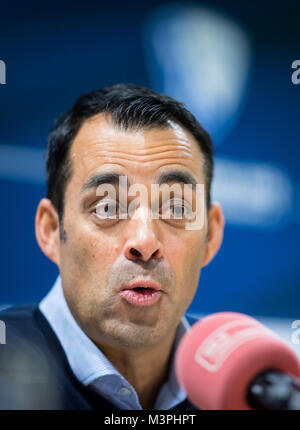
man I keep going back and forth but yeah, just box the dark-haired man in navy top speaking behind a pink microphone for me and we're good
[0,85,224,410]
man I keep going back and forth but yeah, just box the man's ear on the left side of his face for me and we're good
[35,199,60,266]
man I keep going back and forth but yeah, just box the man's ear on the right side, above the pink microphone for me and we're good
[202,203,225,267]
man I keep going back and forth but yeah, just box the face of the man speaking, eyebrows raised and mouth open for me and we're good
[58,114,207,348]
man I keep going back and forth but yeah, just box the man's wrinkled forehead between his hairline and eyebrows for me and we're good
[70,114,204,183]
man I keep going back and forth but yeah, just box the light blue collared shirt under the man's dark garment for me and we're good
[39,276,190,410]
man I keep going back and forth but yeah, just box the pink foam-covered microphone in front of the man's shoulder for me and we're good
[175,312,300,410]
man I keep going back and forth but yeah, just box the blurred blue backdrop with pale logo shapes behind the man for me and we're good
[0,0,300,330]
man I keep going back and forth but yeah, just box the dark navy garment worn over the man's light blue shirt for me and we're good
[0,305,197,411]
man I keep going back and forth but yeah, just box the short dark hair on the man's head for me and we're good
[46,84,213,220]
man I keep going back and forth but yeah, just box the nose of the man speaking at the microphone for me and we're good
[124,206,162,262]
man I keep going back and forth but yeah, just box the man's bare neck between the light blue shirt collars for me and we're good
[98,330,176,409]
